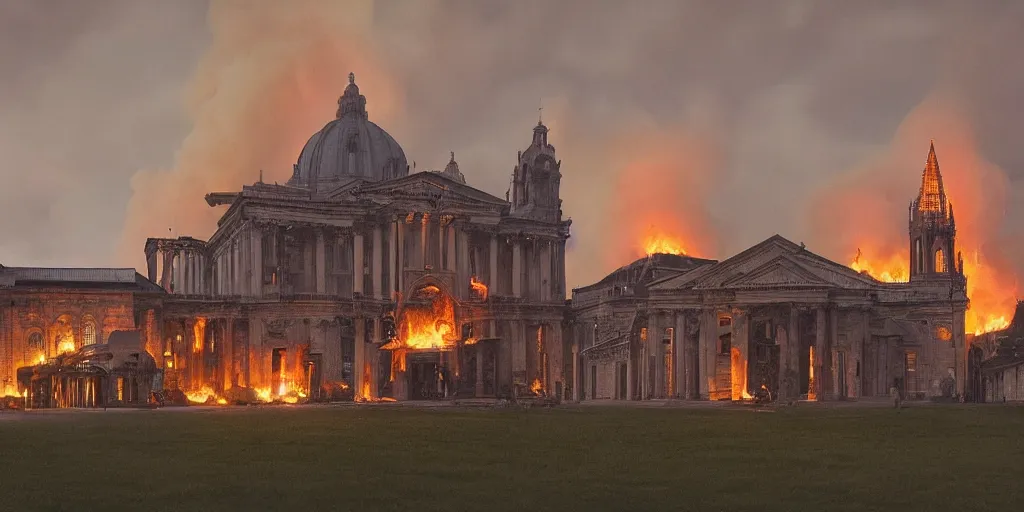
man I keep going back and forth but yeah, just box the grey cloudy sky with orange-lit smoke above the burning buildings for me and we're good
[0,0,1024,299]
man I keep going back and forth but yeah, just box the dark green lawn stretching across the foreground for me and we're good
[0,407,1024,512]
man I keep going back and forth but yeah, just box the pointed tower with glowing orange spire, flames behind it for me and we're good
[909,140,964,282]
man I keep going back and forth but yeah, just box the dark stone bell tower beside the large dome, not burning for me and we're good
[510,120,562,222]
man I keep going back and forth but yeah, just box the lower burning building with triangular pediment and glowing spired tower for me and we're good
[572,142,968,400]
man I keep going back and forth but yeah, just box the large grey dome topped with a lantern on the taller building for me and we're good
[289,73,409,188]
